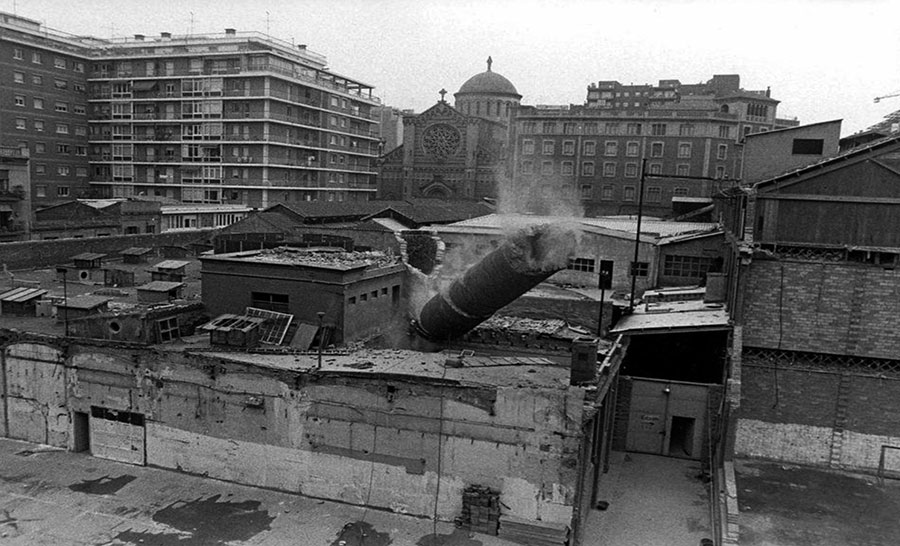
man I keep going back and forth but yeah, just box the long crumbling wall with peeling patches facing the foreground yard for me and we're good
[3,342,584,525]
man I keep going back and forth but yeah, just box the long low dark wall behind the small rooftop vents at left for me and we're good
[0,230,215,270]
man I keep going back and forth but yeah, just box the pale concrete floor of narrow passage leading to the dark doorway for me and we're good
[585,451,712,546]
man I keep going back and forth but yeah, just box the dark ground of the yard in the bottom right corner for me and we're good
[734,460,900,546]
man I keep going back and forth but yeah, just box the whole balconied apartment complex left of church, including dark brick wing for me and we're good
[0,14,379,212]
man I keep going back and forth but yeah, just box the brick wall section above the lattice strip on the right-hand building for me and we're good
[743,259,900,359]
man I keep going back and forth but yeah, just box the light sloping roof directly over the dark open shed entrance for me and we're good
[610,301,731,334]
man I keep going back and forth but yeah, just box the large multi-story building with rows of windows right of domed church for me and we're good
[513,75,798,216]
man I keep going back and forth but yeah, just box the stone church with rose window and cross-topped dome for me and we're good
[378,57,522,200]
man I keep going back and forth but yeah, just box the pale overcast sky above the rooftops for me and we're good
[12,0,900,135]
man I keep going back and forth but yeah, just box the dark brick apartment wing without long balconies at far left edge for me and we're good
[0,13,99,208]
